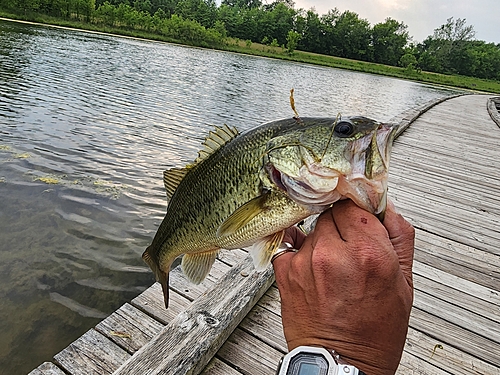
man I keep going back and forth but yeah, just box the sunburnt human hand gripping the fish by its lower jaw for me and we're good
[273,200,415,375]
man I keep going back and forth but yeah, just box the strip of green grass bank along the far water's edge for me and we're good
[0,11,500,94]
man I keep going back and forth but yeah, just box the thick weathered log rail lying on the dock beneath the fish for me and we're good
[116,258,274,375]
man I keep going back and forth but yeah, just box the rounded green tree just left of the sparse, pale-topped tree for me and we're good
[372,18,409,66]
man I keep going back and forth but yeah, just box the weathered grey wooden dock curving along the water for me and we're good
[30,95,500,375]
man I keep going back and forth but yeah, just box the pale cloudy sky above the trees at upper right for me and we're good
[294,0,500,43]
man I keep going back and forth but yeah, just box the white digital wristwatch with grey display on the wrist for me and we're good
[276,346,366,375]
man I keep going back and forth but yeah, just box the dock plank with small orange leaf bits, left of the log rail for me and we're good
[95,303,164,354]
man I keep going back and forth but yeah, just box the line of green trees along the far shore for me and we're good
[0,0,500,81]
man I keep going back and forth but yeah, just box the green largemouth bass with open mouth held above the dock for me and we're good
[142,115,397,308]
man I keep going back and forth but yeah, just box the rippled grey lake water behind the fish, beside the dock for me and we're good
[0,21,457,375]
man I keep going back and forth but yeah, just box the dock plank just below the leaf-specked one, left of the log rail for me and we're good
[54,329,130,375]
